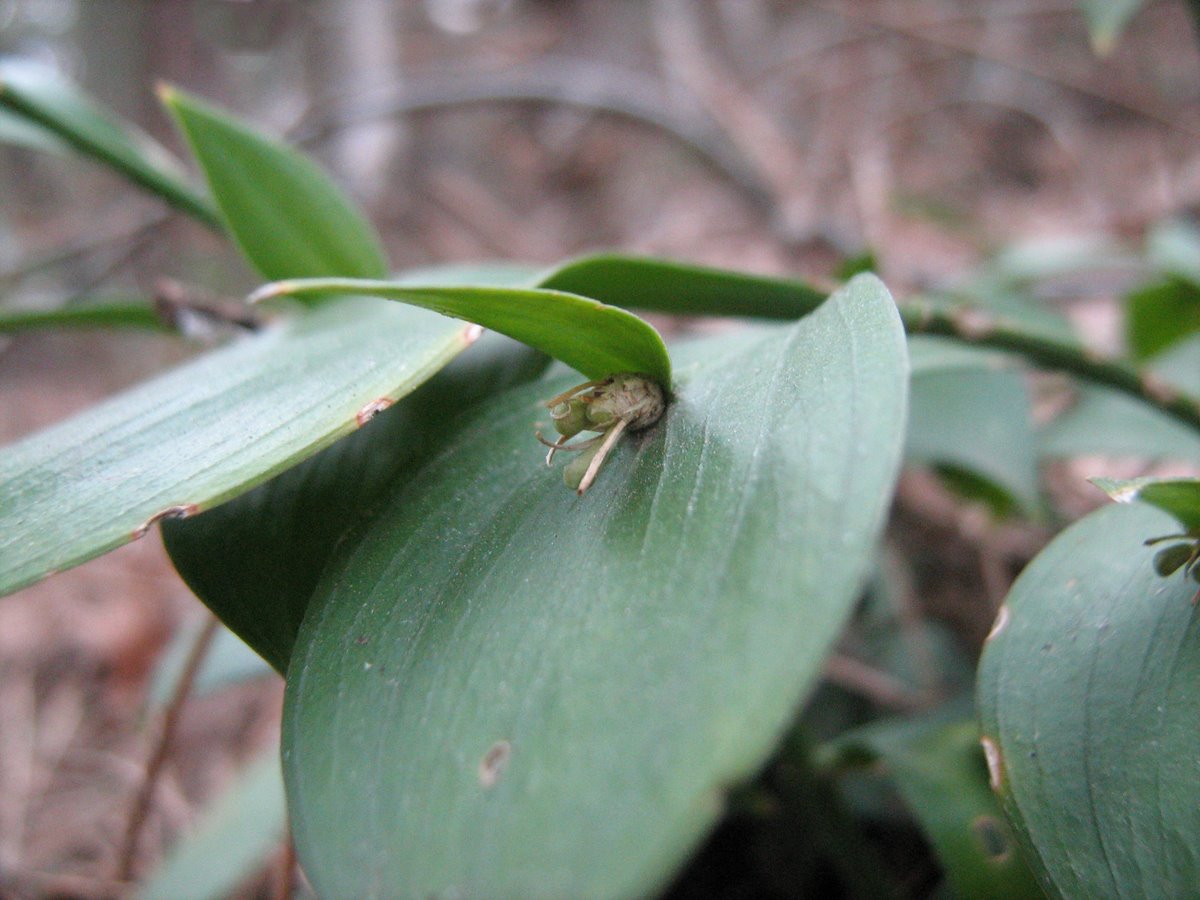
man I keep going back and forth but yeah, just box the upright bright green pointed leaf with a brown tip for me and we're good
[160,85,388,278]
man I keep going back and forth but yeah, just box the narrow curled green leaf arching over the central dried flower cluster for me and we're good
[260,278,671,388]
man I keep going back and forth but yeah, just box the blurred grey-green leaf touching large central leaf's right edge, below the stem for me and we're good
[905,367,1038,512]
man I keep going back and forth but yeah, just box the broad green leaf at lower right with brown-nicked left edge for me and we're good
[978,504,1200,898]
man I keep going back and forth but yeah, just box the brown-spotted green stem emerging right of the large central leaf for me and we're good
[898,300,1200,432]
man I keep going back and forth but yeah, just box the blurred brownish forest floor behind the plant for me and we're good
[0,0,1200,896]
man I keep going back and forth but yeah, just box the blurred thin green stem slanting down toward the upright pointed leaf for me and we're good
[0,80,224,233]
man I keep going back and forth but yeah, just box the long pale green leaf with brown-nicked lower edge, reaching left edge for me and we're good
[0,298,472,602]
